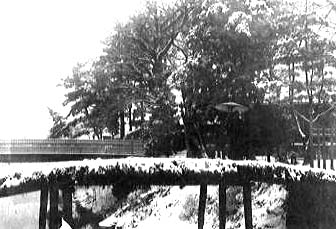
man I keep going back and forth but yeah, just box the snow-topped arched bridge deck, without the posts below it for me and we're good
[0,158,336,196]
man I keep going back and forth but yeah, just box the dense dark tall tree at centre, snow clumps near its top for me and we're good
[176,0,280,158]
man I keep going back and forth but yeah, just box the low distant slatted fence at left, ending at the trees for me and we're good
[0,139,144,162]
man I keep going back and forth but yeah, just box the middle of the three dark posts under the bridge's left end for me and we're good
[49,182,59,229]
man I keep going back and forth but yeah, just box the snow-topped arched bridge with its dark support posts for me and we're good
[0,158,336,229]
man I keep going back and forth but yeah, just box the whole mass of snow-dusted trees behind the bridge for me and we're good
[50,0,336,160]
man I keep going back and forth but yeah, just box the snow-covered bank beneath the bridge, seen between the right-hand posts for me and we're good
[100,183,287,229]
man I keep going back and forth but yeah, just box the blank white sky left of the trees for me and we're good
[0,0,147,139]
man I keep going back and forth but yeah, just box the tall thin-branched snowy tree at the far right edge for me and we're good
[268,1,336,163]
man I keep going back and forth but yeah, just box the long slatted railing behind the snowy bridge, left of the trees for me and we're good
[0,139,144,162]
